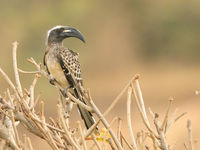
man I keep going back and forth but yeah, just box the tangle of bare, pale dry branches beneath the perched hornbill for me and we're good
[0,42,194,150]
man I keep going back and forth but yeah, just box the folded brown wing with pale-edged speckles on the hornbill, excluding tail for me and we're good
[59,48,83,87]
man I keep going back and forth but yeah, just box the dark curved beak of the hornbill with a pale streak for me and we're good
[61,27,85,43]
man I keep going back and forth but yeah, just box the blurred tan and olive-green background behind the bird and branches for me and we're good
[0,0,200,150]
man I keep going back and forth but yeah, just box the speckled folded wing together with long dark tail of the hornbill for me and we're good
[58,48,95,129]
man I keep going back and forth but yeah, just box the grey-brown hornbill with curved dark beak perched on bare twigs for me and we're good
[44,26,95,129]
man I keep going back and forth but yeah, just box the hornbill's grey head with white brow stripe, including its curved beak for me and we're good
[47,26,85,44]
